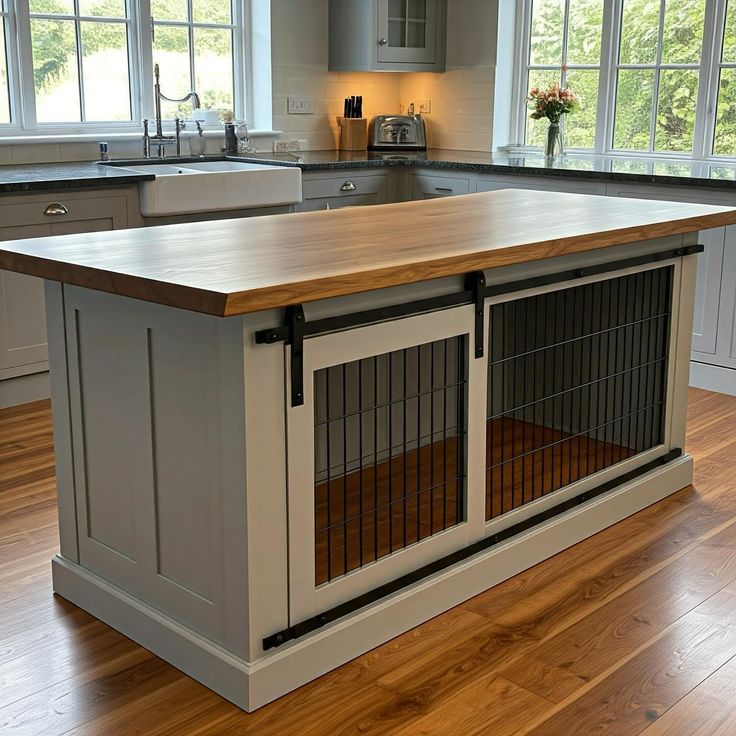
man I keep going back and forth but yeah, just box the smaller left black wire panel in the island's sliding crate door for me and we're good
[314,336,468,585]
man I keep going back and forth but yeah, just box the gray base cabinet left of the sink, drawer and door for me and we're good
[0,192,129,380]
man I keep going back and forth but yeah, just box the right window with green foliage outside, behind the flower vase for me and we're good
[517,0,736,157]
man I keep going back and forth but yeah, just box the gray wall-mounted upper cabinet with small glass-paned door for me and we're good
[329,0,447,72]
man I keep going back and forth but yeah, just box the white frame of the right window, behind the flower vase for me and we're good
[508,0,736,162]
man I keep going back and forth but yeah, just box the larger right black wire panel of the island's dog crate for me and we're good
[486,266,674,520]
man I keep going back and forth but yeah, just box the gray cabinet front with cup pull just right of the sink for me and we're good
[296,171,388,212]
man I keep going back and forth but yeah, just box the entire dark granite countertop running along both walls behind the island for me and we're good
[0,149,736,193]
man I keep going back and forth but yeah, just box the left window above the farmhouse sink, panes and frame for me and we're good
[0,0,271,135]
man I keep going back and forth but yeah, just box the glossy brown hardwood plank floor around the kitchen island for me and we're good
[0,390,736,736]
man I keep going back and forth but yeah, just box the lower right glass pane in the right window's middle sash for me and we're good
[654,69,698,151]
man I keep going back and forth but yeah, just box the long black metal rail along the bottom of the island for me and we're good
[263,448,682,650]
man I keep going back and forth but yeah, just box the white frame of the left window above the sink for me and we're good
[0,0,272,141]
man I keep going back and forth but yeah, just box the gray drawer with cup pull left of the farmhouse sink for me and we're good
[0,192,127,230]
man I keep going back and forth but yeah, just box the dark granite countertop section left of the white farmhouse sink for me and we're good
[0,162,156,192]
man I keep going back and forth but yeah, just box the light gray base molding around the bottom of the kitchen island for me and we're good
[52,454,692,711]
